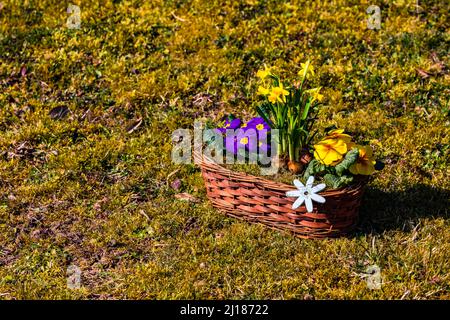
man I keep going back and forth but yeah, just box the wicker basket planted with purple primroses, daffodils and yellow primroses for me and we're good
[200,61,382,238]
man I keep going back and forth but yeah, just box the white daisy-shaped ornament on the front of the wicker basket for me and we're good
[286,176,326,212]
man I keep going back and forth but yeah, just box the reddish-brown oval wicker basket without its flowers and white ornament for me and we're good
[195,153,367,238]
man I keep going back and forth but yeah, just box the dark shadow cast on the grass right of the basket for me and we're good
[355,184,450,234]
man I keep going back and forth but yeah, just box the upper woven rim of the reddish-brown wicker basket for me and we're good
[194,150,369,196]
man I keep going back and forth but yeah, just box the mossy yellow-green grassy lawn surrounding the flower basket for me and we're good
[0,0,450,299]
